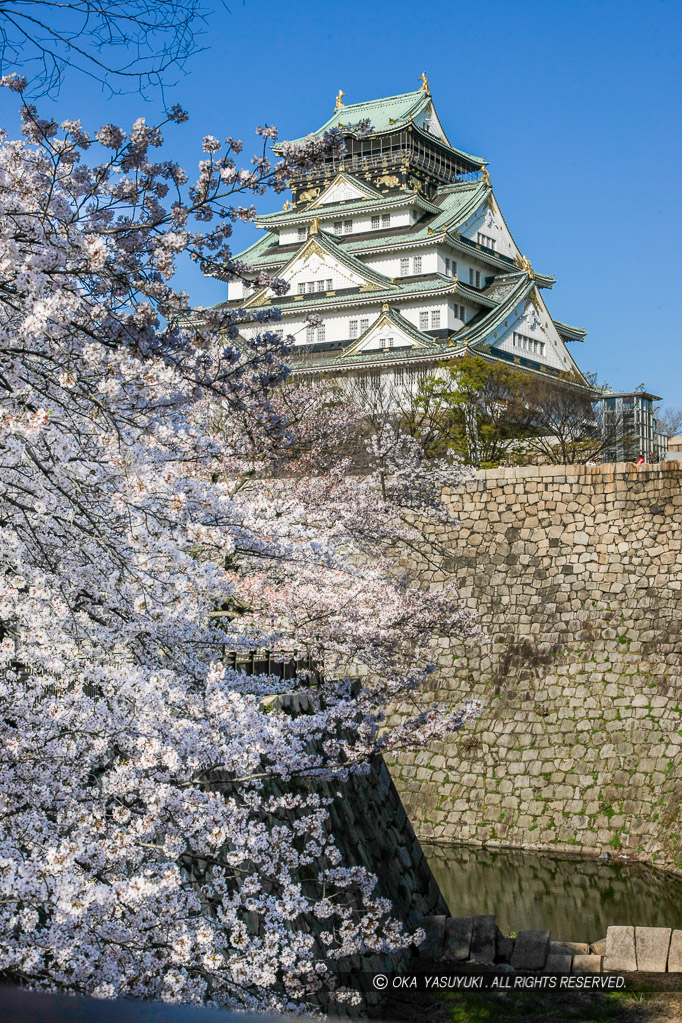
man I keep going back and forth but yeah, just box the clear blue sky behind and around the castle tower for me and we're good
[0,0,682,406]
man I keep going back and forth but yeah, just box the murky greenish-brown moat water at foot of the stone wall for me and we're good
[422,843,682,941]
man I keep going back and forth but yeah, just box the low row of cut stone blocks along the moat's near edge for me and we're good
[418,916,682,974]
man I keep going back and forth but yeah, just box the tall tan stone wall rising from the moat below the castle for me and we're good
[391,462,682,870]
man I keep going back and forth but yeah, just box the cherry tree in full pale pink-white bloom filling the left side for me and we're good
[0,78,476,1008]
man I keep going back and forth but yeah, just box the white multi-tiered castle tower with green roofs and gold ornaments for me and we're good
[217,76,587,383]
